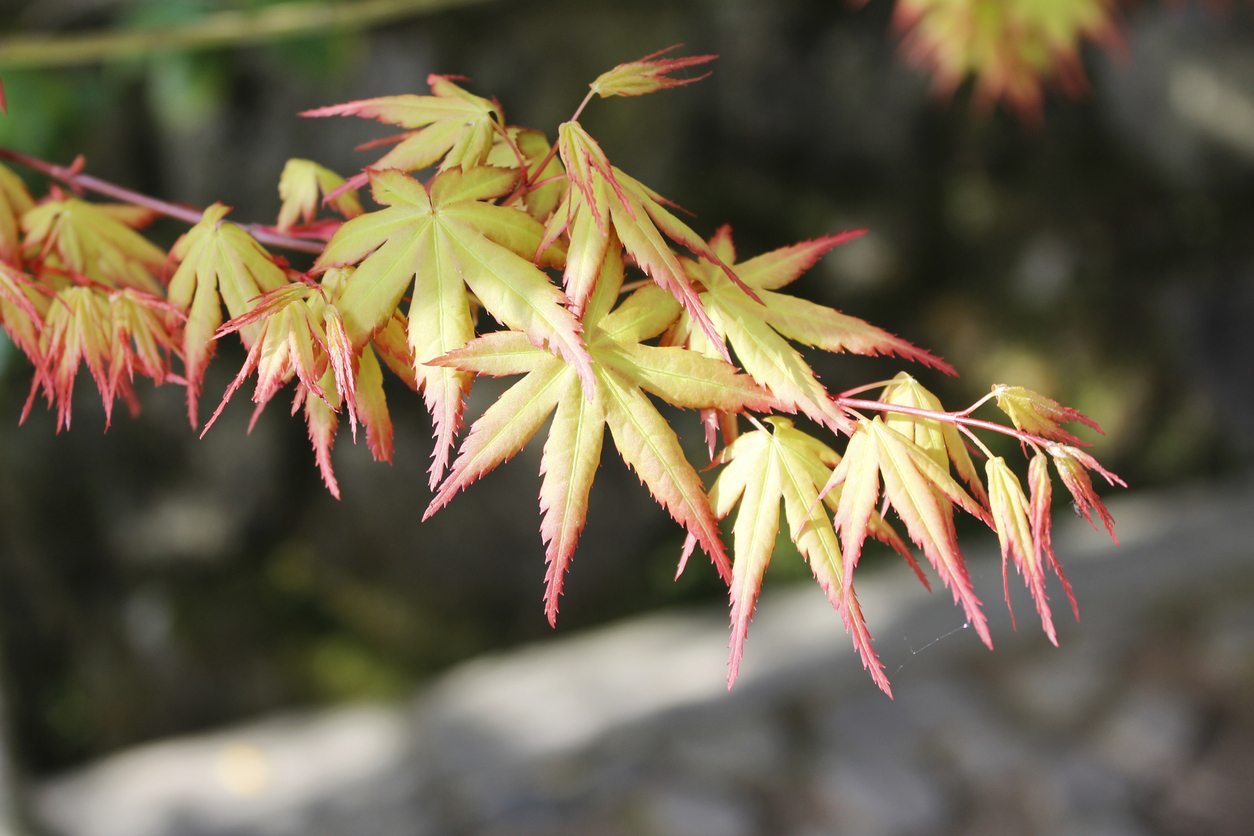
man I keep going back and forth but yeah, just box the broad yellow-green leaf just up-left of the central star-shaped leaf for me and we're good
[314,168,592,488]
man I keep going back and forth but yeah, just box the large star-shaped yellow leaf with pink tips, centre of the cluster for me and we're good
[424,246,772,623]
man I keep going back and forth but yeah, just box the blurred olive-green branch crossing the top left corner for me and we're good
[0,0,494,68]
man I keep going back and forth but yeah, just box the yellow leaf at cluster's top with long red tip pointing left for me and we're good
[301,74,502,194]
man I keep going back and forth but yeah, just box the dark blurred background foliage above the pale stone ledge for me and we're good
[0,0,1254,771]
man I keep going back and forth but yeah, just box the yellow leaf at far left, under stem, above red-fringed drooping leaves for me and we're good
[21,198,166,295]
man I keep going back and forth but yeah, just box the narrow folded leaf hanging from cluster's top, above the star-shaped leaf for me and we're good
[538,122,752,350]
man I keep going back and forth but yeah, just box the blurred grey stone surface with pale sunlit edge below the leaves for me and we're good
[35,484,1254,836]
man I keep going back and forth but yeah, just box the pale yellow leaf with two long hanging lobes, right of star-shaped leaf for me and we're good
[710,417,904,697]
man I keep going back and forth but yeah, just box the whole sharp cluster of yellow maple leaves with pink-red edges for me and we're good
[0,50,1119,692]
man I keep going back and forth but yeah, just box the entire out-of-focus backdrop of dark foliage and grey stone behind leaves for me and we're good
[0,0,1254,836]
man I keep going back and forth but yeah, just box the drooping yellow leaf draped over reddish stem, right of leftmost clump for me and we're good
[168,203,287,427]
